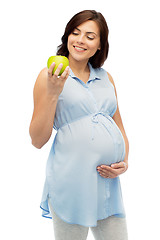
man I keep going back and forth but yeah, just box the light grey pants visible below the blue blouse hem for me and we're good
[49,201,128,240]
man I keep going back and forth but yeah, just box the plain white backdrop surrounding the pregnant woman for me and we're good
[0,0,160,240]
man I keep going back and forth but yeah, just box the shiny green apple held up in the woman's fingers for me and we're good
[47,55,69,76]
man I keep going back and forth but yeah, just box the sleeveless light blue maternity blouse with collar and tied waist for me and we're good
[40,64,125,227]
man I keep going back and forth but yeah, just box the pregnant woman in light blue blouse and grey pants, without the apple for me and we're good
[30,10,129,240]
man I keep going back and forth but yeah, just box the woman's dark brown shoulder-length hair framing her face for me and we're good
[57,10,109,68]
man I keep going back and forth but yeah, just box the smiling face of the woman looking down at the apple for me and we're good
[67,20,100,62]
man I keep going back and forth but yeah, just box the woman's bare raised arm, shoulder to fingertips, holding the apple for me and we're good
[29,64,69,148]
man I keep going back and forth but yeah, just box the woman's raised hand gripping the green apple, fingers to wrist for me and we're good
[47,62,70,98]
